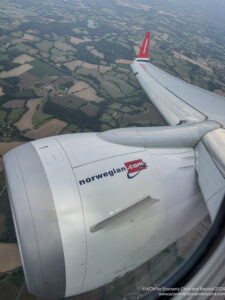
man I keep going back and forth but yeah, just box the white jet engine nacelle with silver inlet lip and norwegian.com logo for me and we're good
[4,133,207,298]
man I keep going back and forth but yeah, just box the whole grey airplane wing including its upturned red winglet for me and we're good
[131,32,225,220]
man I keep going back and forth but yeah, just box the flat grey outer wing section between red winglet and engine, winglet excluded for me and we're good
[131,60,225,126]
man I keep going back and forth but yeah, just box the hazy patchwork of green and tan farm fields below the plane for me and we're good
[0,0,225,299]
